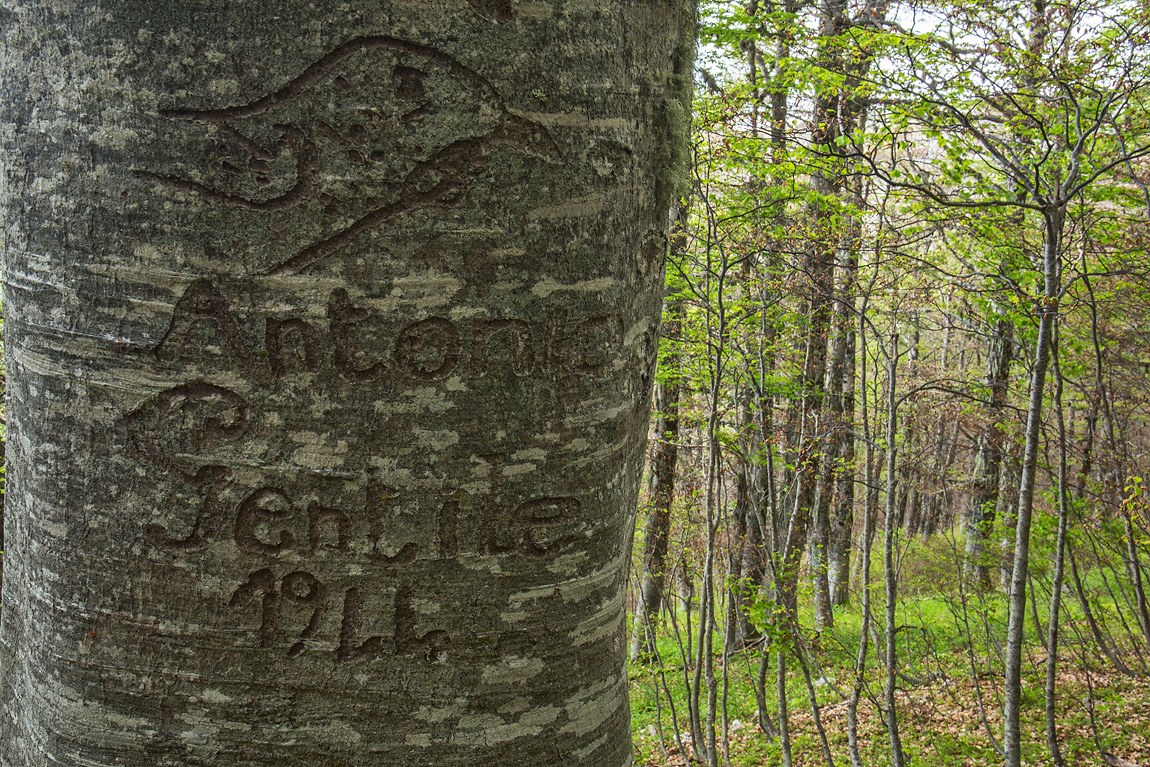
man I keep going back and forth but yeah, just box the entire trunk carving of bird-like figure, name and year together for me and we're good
[123,37,623,664]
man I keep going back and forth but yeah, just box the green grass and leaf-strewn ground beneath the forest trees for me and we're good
[630,538,1150,767]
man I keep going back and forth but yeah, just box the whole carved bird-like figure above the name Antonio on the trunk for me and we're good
[138,36,560,275]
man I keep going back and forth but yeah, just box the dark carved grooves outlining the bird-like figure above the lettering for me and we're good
[136,36,561,275]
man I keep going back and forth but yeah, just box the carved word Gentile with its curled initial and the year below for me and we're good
[124,382,581,662]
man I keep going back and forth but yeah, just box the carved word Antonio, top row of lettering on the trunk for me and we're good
[153,279,622,383]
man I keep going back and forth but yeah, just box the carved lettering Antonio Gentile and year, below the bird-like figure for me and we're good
[131,290,622,662]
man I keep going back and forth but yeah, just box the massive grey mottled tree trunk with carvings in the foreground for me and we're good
[0,0,691,767]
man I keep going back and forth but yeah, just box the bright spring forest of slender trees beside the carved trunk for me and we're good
[630,0,1150,767]
